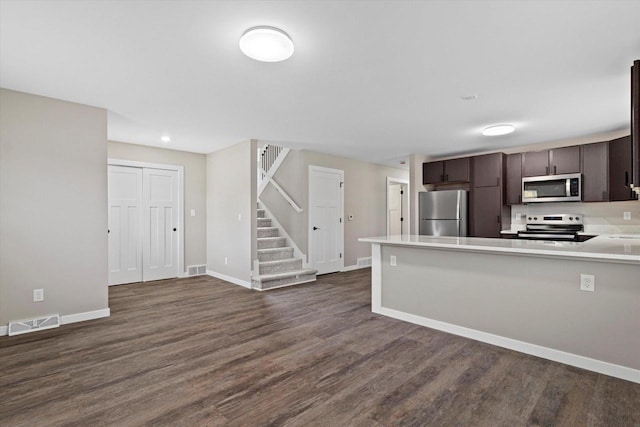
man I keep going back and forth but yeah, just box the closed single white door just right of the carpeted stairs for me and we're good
[309,166,344,274]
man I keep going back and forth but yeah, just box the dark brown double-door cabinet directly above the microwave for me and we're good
[522,145,580,176]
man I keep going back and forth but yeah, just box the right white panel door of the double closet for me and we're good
[142,168,179,281]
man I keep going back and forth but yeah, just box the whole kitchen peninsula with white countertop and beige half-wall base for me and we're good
[359,235,640,383]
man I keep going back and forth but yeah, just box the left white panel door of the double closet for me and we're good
[108,166,142,285]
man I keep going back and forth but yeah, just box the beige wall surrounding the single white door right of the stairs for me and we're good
[260,150,409,267]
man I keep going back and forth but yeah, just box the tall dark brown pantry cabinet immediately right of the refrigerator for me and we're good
[469,153,506,237]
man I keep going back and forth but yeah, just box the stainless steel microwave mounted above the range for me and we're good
[522,173,582,203]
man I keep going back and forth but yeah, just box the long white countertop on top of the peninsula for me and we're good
[358,234,640,264]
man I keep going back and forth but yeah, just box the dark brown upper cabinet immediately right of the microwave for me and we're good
[582,142,609,202]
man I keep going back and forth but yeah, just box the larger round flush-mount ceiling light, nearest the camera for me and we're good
[240,26,293,62]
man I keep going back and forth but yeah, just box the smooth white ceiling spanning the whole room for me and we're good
[0,0,640,163]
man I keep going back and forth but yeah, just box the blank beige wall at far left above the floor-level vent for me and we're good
[0,89,108,325]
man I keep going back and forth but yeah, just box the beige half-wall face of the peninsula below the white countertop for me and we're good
[381,245,640,369]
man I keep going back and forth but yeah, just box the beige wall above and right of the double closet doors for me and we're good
[107,141,207,270]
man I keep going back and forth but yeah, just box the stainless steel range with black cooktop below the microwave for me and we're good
[518,214,584,242]
